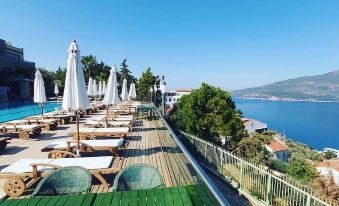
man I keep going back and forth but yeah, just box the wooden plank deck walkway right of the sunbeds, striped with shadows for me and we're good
[91,120,196,193]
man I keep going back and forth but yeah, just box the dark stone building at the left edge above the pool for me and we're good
[0,39,35,101]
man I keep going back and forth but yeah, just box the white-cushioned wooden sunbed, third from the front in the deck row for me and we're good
[69,127,130,140]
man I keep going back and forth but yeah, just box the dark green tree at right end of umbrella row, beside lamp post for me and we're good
[136,67,158,101]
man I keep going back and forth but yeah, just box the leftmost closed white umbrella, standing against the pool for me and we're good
[33,70,46,117]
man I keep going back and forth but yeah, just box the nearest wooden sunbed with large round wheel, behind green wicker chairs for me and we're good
[0,156,123,197]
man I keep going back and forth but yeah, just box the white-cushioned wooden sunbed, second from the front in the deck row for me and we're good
[41,139,127,157]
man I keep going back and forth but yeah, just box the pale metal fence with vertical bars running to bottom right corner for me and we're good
[181,132,338,206]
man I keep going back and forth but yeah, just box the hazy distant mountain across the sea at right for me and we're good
[232,70,339,101]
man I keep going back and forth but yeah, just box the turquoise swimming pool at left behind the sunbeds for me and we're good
[0,102,61,122]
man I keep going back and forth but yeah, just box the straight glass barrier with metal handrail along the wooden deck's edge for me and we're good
[156,110,230,206]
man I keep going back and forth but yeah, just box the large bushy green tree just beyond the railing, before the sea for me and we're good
[169,83,244,149]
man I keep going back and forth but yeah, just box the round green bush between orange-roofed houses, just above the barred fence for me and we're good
[286,158,318,184]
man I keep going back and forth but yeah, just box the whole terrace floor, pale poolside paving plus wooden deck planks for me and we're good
[0,111,196,198]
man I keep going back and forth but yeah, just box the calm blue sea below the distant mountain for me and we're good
[234,98,339,150]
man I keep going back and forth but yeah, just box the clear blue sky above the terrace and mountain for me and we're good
[0,0,339,90]
